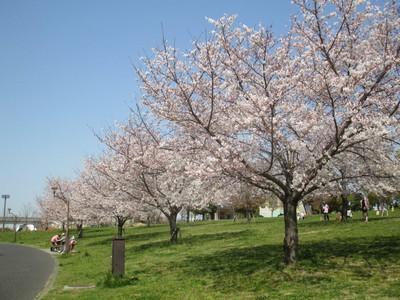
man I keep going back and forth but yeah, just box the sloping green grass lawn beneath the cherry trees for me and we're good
[2,210,400,299]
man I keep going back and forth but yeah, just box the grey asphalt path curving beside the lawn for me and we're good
[0,243,57,300]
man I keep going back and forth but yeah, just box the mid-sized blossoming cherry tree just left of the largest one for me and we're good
[95,108,225,243]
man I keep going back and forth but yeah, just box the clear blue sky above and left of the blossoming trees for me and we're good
[0,0,295,216]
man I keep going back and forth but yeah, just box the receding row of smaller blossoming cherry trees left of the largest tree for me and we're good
[38,109,234,243]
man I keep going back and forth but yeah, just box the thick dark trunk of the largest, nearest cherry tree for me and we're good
[283,199,299,265]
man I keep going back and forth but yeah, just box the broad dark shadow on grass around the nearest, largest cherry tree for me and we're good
[178,236,400,291]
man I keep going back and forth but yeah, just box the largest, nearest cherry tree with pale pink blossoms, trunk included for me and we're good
[135,0,400,264]
